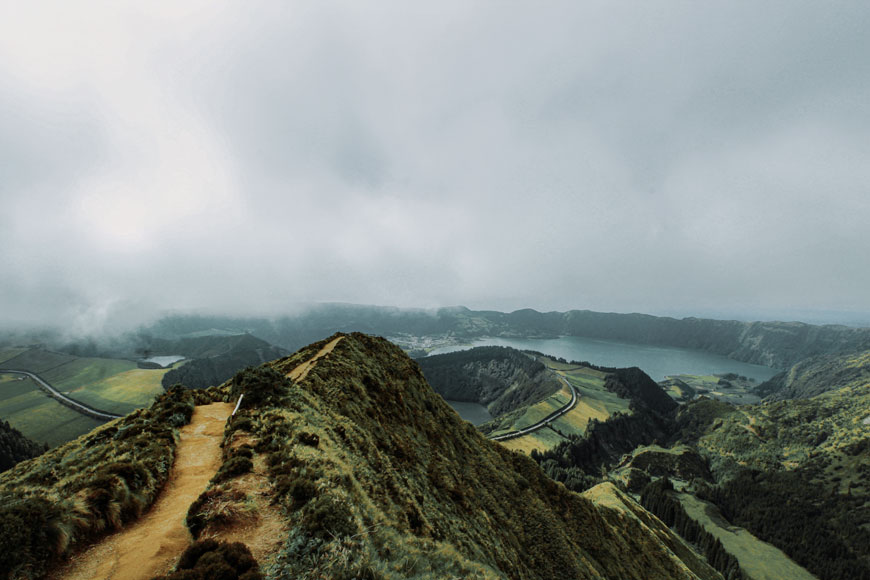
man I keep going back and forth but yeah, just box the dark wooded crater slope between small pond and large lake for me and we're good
[417,346,561,416]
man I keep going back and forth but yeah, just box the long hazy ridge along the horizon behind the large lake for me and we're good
[145,304,870,368]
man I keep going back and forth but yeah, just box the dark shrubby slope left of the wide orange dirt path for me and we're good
[0,389,194,578]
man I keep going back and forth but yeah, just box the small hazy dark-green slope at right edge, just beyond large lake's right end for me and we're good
[756,350,870,401]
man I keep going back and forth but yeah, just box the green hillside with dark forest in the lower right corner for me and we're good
[678,382,870,579]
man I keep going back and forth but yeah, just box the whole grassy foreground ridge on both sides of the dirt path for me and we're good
[0,334,721,580]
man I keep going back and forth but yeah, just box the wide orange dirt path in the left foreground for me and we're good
[54,403,233,580]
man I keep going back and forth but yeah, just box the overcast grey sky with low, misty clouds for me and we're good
[0,0,870,327]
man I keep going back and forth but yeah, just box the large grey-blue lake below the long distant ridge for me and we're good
[430,336,780,382]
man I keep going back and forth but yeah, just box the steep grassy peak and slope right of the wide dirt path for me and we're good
[211,334,715,579]
